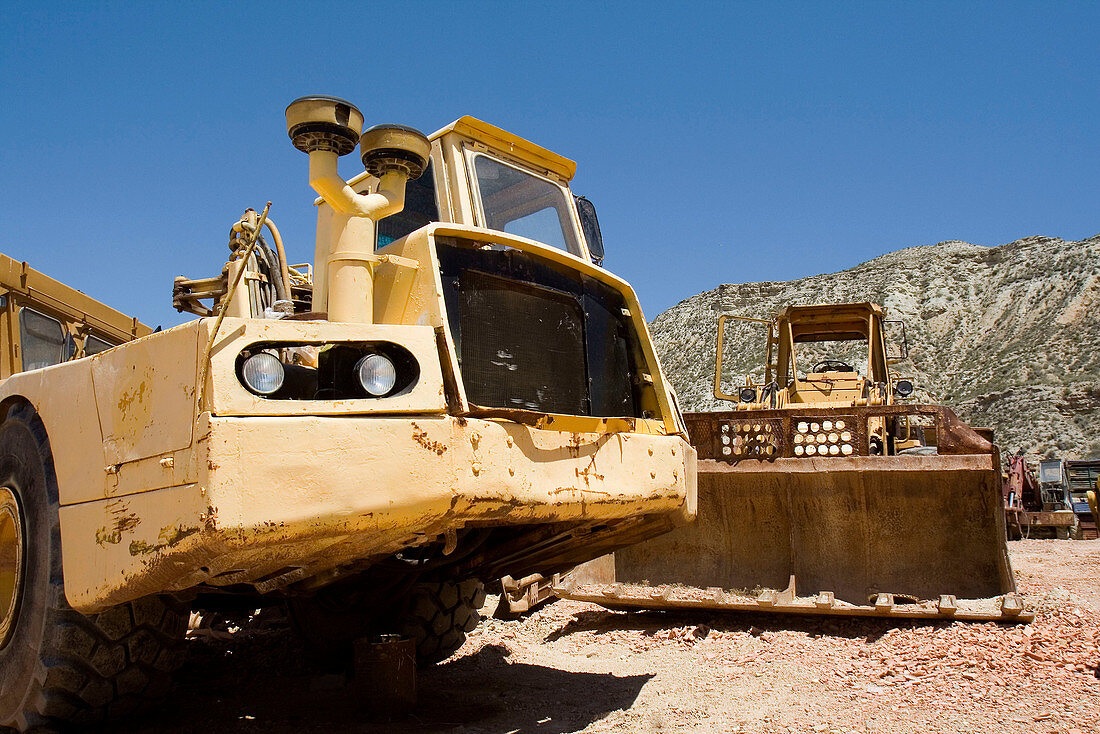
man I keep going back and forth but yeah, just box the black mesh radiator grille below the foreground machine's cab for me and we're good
[438,238,639,417]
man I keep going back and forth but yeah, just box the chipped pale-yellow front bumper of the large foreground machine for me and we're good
[62,416,695,612]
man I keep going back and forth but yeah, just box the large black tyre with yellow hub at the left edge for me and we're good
[0,405,187,732]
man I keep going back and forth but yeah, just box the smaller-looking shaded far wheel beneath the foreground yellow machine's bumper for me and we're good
[398,579,485,666]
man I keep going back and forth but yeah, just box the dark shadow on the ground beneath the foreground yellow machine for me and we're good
[110,631,652,734]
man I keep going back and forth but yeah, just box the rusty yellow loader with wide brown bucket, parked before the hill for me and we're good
[556,303,1033,621]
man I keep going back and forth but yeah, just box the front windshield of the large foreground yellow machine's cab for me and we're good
[474,154,581,256]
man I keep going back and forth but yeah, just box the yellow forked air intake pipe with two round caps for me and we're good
[286,96,431,324]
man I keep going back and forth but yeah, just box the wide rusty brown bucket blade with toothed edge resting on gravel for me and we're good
[557,453,1034,622]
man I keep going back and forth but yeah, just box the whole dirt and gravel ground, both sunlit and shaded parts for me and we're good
[112,540,1100,734]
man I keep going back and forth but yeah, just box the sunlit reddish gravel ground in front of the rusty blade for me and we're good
[460,540,1100,734]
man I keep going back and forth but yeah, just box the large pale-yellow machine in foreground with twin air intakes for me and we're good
[0,97,695,731]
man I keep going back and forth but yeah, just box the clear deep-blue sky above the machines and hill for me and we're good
[0,1,1100,327]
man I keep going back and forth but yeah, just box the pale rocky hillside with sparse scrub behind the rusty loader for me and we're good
[650,234,1100,459]
